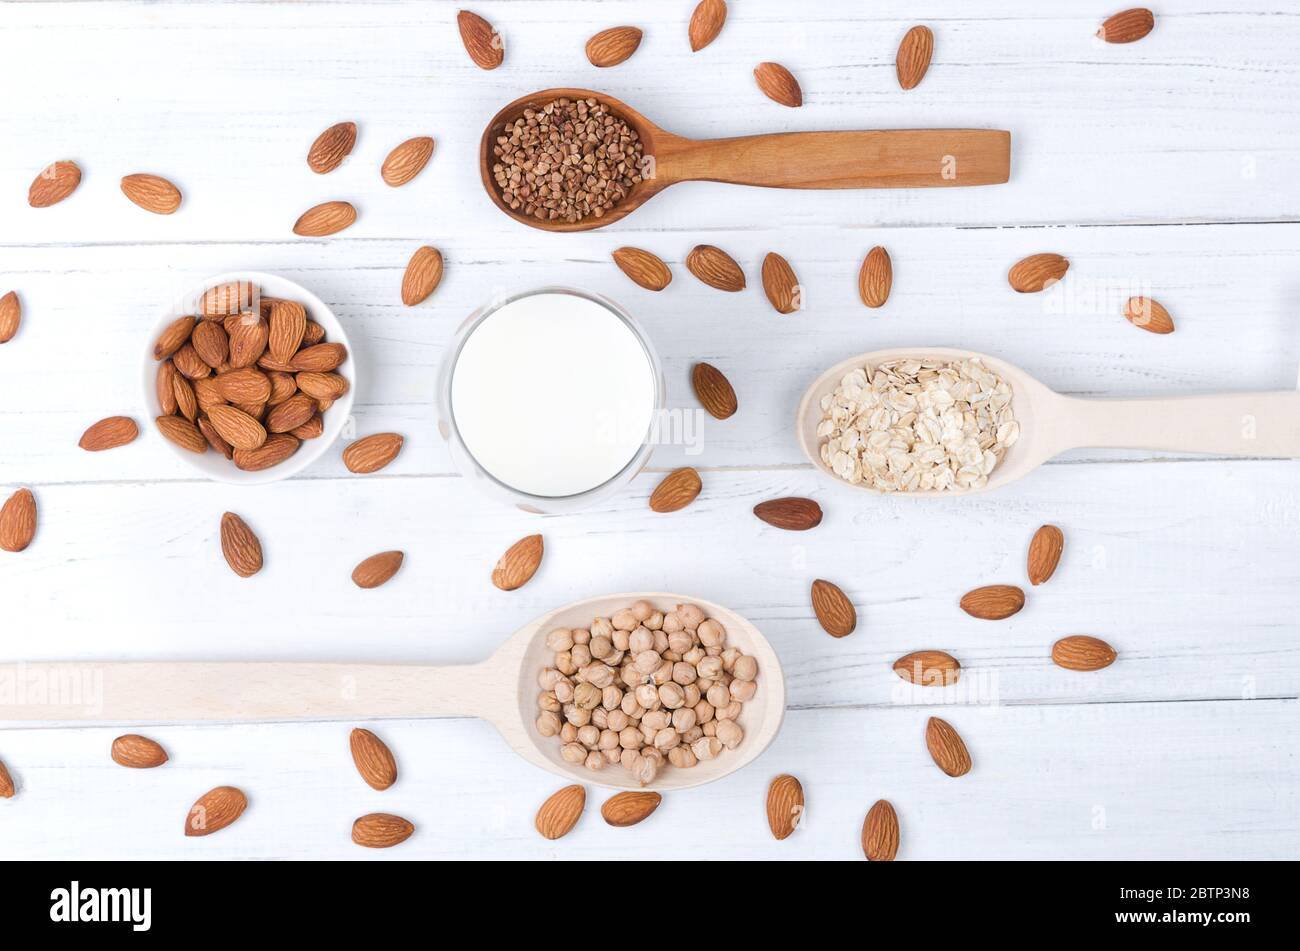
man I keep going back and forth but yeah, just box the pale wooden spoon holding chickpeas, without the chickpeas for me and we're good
[0,592,785,791]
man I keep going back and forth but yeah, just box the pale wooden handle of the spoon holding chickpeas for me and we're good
[0,663,504,722]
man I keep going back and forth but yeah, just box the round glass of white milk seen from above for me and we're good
[438,287,664,513]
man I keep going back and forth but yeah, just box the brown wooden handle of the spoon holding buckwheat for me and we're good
[659,129,1011,188]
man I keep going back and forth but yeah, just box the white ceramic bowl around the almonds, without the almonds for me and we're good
[142,270,359,486]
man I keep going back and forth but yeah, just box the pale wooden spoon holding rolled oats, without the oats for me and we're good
[796,347,1300,496]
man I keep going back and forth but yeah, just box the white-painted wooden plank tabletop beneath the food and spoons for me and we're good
[0,0,1300,859]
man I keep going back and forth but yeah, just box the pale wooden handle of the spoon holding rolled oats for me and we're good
[1054,390,1300,457]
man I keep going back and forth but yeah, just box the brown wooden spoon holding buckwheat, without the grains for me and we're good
[478,88,1011,231]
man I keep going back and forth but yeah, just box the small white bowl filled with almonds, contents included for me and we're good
[143,272,356,485]
